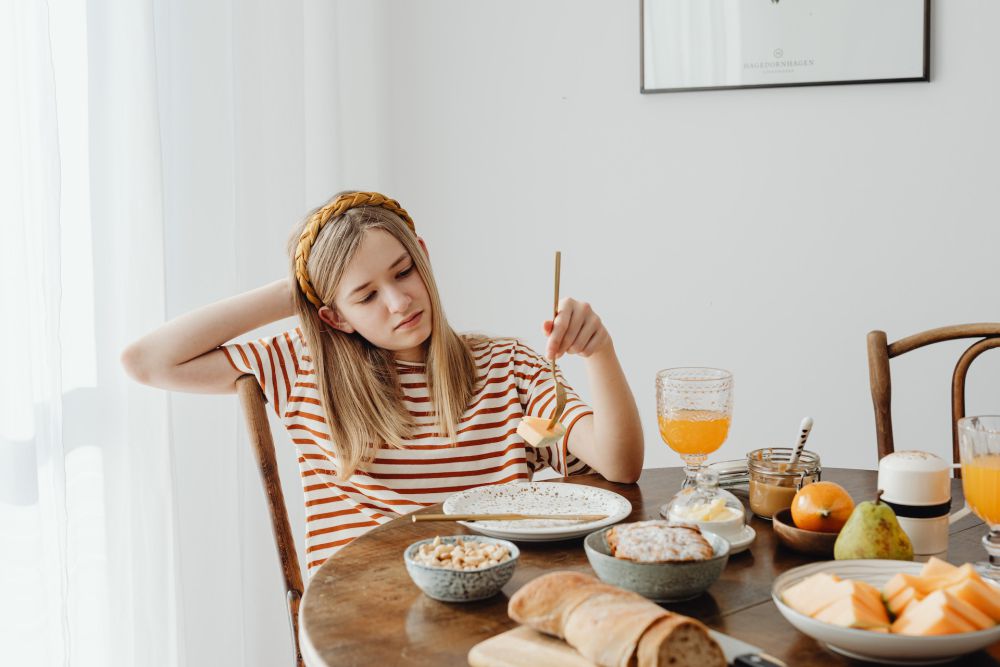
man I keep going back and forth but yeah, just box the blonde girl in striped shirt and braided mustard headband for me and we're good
[122,192,643,576]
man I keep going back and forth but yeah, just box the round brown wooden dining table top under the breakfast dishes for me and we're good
[299,468,1000,667]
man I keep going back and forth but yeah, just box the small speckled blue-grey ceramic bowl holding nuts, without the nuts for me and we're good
[403,535,521,602]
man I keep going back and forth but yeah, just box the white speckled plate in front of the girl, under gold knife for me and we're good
[444,482,632,542]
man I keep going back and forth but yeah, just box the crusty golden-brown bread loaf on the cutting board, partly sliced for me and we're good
[507,572,726,667]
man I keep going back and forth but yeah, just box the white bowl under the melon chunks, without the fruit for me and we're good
[771,560,1000,665]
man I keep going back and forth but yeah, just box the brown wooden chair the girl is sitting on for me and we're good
[236,375,304,667]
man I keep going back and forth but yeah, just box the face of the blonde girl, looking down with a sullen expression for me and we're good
[319,229,431,361]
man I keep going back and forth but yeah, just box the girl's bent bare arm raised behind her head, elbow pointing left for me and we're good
[122,279,294,394]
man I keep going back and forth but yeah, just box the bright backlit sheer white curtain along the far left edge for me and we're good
[0,0,181,667]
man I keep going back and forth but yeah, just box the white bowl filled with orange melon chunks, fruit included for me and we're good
[771,558,1000,665]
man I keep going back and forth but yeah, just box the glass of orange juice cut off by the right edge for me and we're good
[958,416,1000,581]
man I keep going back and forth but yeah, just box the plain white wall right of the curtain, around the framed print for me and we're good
[370,0,1000,467]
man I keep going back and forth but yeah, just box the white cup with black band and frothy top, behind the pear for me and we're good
[878,451,969,556]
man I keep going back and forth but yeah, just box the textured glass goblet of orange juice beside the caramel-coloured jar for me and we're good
[656,368,733,500]
